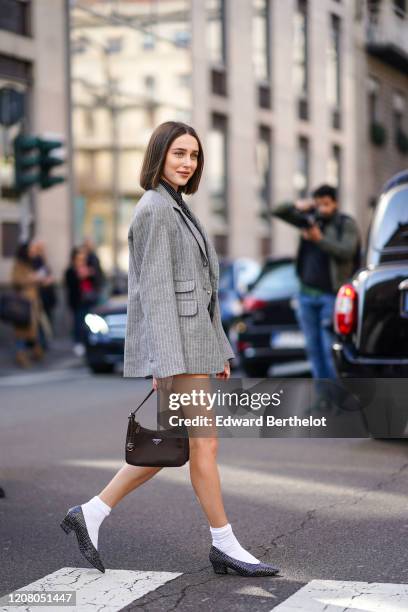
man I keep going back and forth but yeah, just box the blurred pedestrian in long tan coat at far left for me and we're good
[11,242,44,368]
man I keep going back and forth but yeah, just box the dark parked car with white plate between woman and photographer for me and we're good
[235,258,308,378]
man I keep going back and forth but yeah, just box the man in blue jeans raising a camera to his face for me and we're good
[272,185,360,379]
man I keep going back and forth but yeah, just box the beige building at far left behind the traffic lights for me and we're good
[0,0,72,284]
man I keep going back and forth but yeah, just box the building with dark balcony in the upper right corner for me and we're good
[356,0,408,224]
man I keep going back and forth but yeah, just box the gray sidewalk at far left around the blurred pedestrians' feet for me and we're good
[0,325,85,376]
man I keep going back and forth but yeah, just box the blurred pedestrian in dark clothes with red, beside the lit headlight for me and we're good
[65,247,98,357]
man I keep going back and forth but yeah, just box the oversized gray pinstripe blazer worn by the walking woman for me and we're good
[124,185,234,378]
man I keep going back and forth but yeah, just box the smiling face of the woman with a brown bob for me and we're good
[163,134,199,191]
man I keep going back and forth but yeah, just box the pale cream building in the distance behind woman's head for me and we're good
[71,0,192,271]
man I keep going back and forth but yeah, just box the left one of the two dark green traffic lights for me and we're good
[14,134,40,193]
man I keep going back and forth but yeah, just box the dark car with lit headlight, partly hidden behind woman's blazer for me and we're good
[85,295,127,374]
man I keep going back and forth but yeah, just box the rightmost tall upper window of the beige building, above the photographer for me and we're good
[327,15,341,129]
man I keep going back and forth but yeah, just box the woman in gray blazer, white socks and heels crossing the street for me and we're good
[62,121,278,576]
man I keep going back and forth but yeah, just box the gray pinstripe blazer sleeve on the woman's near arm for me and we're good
[132,206,186,378]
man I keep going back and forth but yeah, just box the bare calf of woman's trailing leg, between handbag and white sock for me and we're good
[98,463,162,508]
